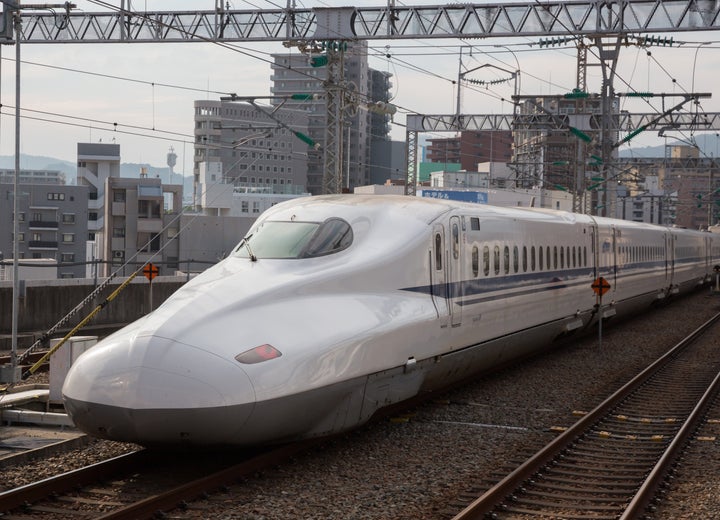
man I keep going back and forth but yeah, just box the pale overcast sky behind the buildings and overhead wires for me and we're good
[0,0,720,179]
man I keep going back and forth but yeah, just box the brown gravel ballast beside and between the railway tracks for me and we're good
[2,290,720,520]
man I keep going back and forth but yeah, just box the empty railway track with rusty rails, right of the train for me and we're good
[454,314,720,520]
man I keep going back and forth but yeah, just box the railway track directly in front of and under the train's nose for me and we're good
[0,441,319,520]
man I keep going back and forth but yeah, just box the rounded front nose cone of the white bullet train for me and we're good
[63,334,255,446]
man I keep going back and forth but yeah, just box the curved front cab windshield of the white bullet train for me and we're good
[233,218,353,260]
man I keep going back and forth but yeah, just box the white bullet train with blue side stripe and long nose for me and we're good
[63,195,720,446]
